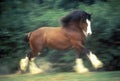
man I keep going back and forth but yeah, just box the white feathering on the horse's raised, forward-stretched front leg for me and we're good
[87,51,103,69]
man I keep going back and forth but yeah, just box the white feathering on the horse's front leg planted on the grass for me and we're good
[74,59,89,73]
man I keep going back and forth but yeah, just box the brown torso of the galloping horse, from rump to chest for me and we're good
[29,27,85,57]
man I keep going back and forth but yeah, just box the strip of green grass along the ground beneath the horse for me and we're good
[0,71,120,81]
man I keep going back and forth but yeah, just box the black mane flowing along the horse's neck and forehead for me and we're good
[61,10,91,27]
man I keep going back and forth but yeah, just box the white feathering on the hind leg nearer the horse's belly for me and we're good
[29,58,43,74]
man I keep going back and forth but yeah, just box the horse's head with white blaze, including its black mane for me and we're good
[61,10,92,36]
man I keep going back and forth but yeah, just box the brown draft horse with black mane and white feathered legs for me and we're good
[20,10,101,73]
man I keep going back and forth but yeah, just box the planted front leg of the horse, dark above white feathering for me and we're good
[74,47,89,73]
